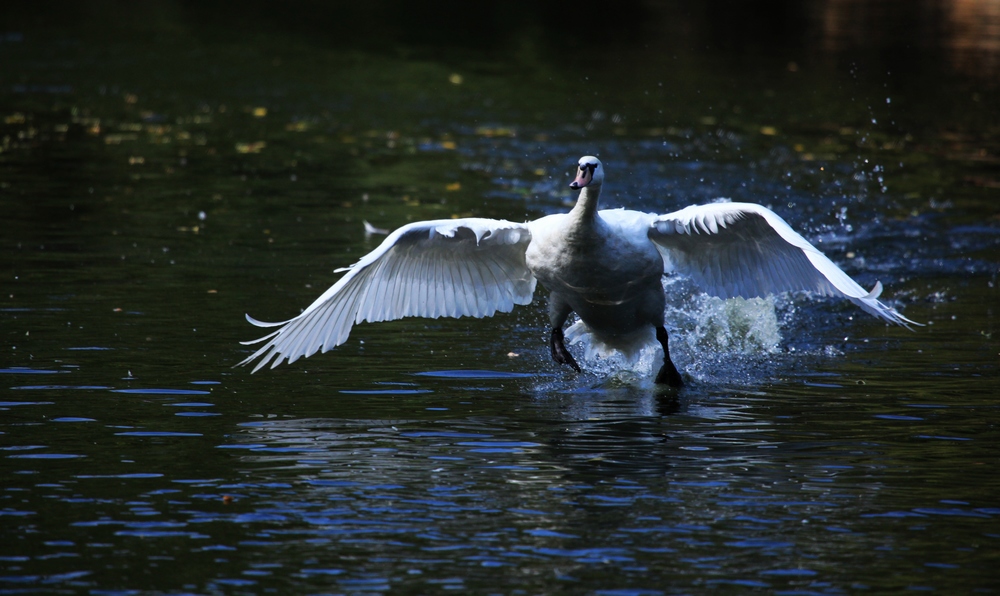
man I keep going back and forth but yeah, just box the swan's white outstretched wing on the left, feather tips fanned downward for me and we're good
[240,218,536,372]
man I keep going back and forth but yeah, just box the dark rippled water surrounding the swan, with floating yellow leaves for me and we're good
[0,1,1000,594]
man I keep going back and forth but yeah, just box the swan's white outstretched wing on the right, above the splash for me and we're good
[649,203,919,326]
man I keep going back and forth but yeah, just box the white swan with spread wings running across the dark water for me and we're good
[237,155,919,387]
